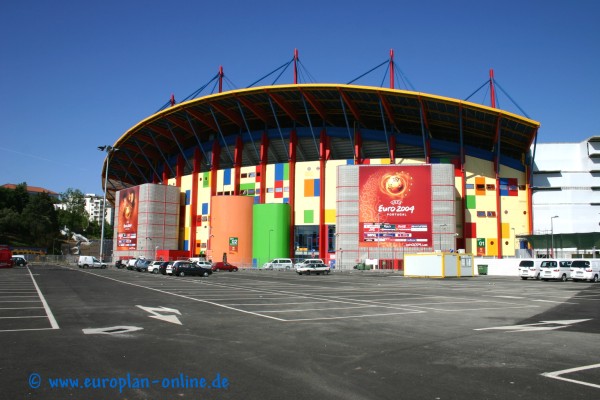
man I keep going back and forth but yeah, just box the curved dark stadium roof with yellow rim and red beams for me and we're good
[103,84,540,203]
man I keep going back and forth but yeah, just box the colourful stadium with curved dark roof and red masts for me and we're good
[102,53,539,269]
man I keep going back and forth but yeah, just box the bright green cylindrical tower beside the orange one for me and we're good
[252,204,290,268]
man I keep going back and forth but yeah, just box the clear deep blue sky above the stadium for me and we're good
[0,0,600,194]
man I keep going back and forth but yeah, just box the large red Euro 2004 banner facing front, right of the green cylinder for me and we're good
[358,165,432,247]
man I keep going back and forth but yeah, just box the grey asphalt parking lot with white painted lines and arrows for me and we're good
[0,265,600,399]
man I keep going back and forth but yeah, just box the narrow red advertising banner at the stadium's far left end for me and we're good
[117,186,140,250]
